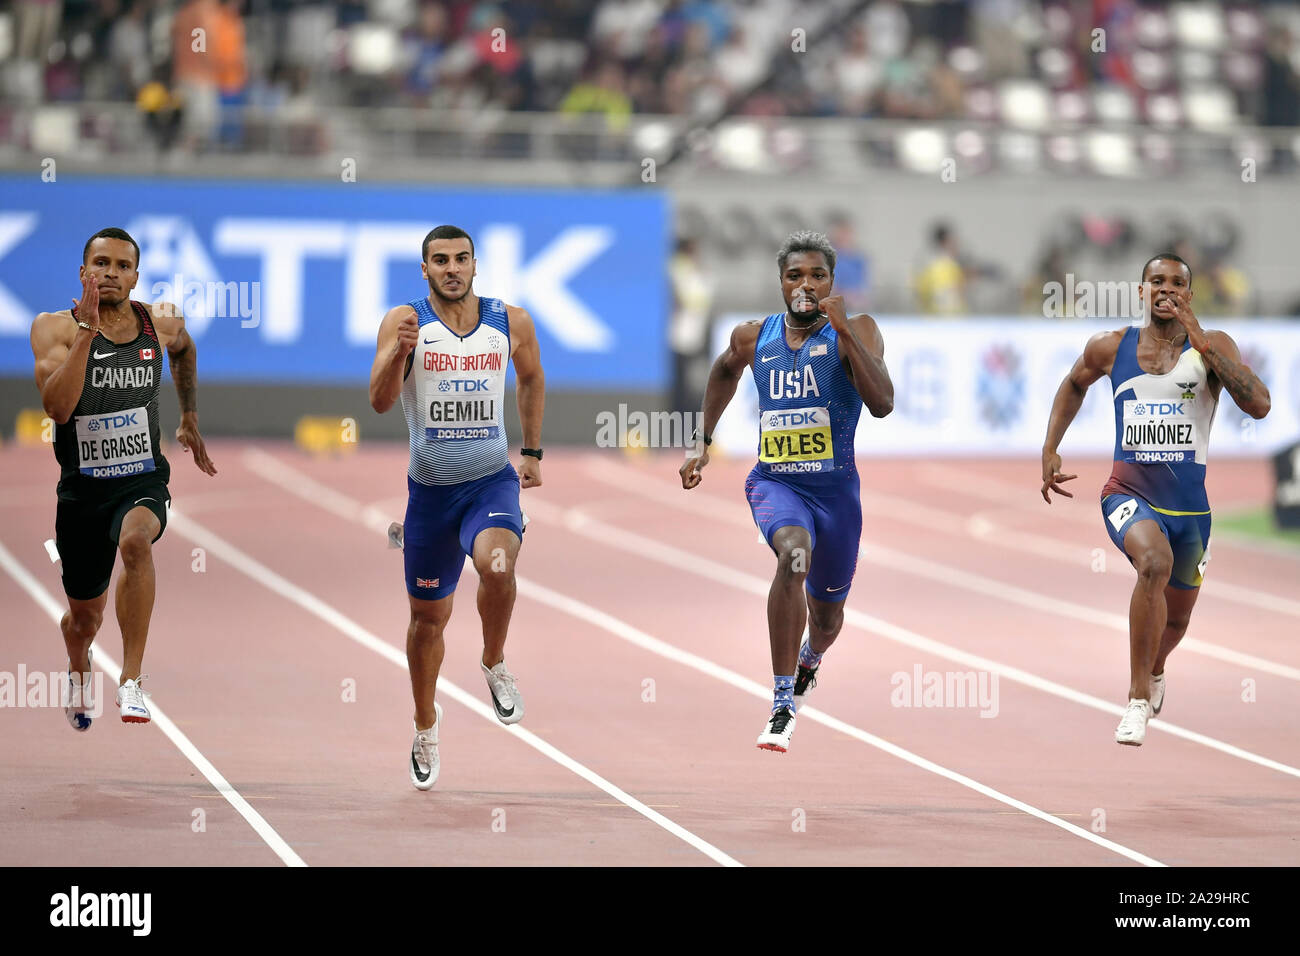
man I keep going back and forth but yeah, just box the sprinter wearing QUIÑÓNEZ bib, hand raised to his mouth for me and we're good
[1043,252,1270,747]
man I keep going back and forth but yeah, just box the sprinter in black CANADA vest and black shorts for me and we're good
[31,228,217,731]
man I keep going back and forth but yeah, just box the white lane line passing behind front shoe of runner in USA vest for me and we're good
[244,451,1165,866]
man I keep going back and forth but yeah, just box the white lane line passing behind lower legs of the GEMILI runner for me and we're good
[169,501,744,866]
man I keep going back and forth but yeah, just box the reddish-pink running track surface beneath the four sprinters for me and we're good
[0,442,1300,865]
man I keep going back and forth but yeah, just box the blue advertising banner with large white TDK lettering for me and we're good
[0,176,670,389]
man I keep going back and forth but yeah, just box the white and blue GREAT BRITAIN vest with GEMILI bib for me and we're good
[402,298,510,485]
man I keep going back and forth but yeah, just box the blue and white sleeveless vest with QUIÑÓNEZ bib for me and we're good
[1101,328,1218,515]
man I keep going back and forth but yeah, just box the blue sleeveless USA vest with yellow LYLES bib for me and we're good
[751,312,862,488]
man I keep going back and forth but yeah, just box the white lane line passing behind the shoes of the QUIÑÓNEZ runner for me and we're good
[574,460,1300,778]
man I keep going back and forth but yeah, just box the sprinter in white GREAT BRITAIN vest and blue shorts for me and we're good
[371,226,545,790]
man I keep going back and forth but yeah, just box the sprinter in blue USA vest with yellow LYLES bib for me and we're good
[680,233,893,753]
